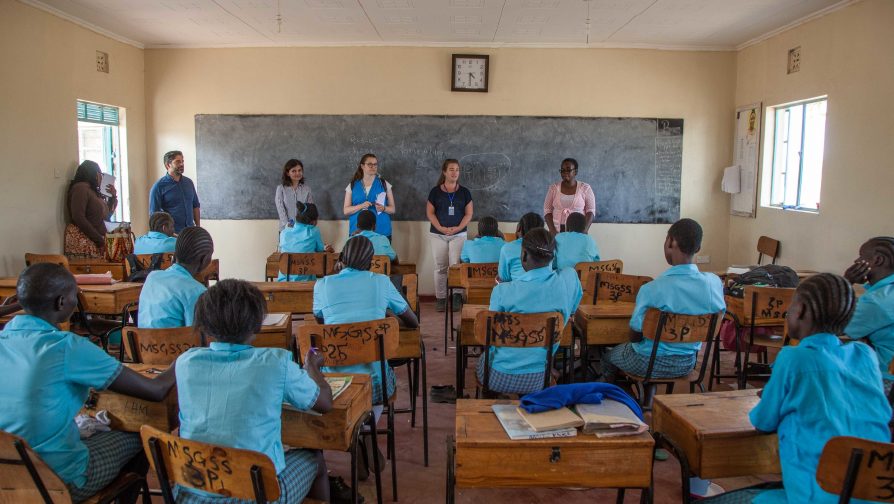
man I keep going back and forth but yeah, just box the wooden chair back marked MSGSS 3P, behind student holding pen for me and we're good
[140,425,280,502]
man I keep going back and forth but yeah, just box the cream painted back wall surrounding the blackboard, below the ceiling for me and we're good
[145,48,735,294]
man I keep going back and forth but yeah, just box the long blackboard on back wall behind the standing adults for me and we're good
[196,115,683,223]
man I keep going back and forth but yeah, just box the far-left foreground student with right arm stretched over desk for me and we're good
[0,263,174,502]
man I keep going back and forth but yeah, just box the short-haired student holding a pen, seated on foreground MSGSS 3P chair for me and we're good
[174,279,340,504]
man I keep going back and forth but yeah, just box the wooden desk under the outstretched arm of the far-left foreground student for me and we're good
[81,364,180,432]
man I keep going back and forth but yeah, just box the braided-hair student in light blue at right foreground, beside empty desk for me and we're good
[702,273,891,503]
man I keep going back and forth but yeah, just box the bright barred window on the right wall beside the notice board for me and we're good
[769,97,826,212]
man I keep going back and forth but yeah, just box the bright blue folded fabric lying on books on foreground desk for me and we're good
[521,382,645,421]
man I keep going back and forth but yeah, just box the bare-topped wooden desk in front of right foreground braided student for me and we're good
[652,389,781,495]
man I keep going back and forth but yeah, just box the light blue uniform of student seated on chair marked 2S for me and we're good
[314,268,410,400]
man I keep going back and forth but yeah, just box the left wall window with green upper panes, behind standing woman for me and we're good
[77,100,130,222]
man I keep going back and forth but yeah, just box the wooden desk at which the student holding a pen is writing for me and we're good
[282,373,372,451]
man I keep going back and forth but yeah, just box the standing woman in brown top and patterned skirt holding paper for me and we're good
[64,160,118,259]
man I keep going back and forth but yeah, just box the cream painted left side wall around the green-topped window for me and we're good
[0,0,148,276]
